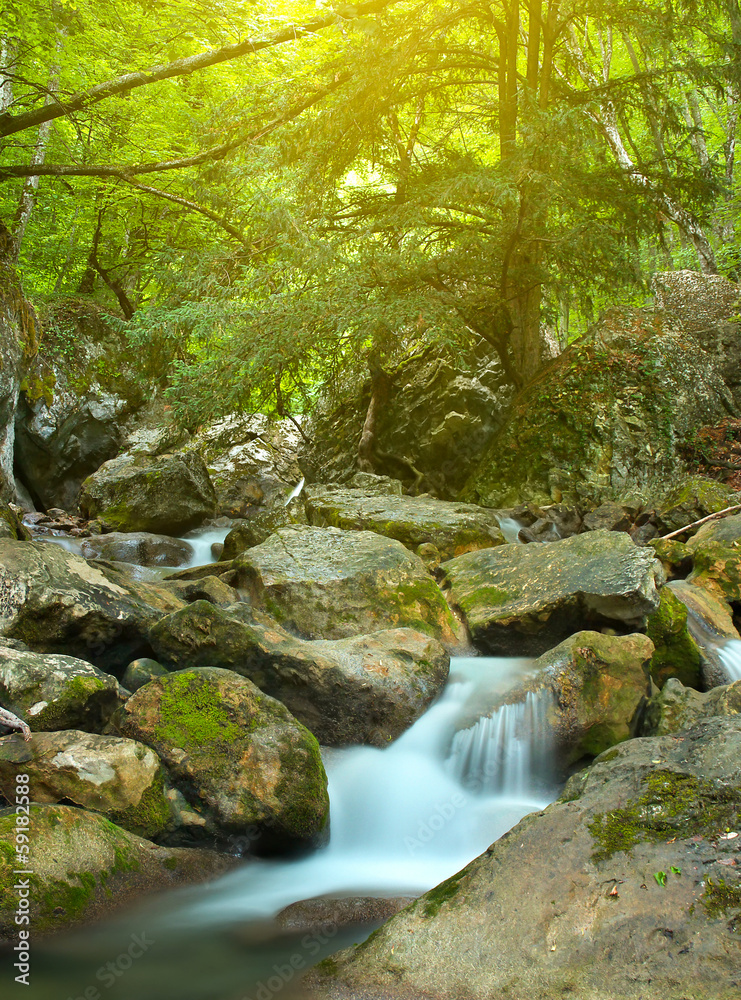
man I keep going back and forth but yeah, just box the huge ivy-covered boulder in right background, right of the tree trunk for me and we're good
[461,309,734,507]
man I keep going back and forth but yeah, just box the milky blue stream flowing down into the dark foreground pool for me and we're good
[8,657,557,1000]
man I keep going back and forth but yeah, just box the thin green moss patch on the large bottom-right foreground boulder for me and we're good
[589,770,741,861]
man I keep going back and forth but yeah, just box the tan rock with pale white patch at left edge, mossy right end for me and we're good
[0,730,175,840]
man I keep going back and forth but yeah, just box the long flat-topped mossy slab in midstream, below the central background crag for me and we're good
[306,486,504,559]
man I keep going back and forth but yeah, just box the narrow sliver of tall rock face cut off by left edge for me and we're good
[0,264,33,500]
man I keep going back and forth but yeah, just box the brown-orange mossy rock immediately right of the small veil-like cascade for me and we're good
[530,632,654,765]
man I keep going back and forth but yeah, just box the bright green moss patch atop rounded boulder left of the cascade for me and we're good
[155,672,243,753]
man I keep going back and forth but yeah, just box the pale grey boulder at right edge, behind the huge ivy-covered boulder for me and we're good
[651,271,741,407]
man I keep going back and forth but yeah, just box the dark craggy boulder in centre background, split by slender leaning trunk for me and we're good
[301,347,513,500]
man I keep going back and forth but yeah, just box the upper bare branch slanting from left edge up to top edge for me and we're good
[0,0,399,137]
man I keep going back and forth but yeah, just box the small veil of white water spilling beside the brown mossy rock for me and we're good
[446,688,553,799]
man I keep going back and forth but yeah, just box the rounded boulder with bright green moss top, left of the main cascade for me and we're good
[114,667,329,849]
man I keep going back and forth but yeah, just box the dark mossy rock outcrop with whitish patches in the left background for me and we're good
[16,299,146,510]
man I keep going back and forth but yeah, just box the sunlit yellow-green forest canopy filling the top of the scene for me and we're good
[0,0,741,422]
